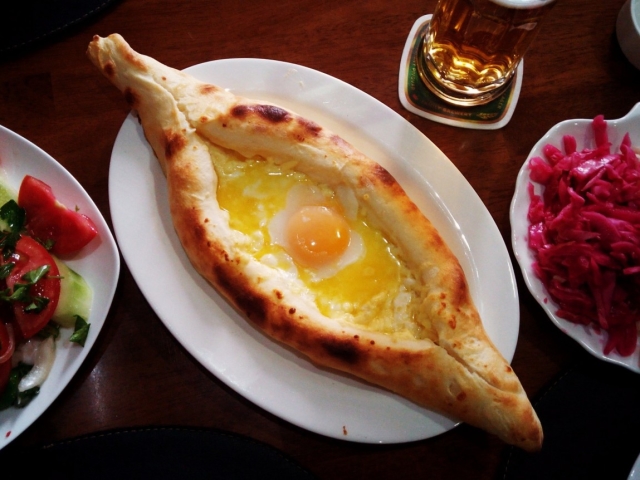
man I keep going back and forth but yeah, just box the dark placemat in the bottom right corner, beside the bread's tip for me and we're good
[499,353,640,480]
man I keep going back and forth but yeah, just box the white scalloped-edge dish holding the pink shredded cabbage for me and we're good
[510,103,640,373]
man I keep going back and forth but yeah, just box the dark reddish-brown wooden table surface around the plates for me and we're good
[0,0,640,478]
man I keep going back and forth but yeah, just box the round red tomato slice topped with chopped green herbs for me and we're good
[6,236,60,339]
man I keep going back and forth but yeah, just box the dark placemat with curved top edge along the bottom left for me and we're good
[0,427,314,480]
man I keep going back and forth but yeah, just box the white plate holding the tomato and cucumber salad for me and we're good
[0,126,120,449]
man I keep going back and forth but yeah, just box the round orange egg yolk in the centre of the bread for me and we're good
[285,205,351,268]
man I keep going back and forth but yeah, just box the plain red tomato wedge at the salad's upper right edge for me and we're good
[18,175,98,255]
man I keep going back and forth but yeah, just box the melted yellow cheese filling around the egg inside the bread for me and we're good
[210,146,426,338]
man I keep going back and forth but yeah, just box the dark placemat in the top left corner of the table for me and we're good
[0,0,121,58]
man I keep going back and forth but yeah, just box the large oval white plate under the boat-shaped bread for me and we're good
[109,59,519,443]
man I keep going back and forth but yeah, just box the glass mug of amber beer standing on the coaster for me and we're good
[417,0,556,105]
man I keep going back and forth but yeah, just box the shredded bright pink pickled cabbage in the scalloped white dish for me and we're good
[528,115,640,356]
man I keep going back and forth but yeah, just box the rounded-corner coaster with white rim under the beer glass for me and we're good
[398,15,524,130]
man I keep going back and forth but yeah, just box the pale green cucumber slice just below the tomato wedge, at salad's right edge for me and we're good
[52,257,93,328]
